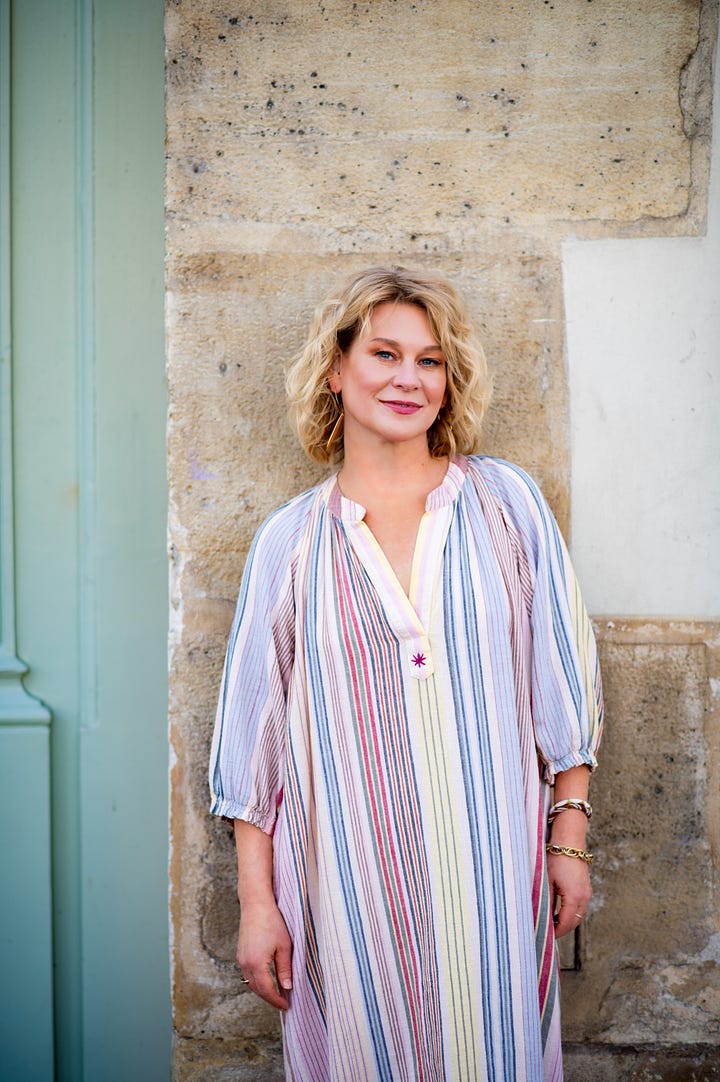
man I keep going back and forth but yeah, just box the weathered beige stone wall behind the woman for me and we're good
[166,0,720,1082]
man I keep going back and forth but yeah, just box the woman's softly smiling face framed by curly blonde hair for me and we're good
[329,302,447,454]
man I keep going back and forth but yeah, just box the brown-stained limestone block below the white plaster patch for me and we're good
[563,621,720,1048]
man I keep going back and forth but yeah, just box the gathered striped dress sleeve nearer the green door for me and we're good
[210,509,294,833]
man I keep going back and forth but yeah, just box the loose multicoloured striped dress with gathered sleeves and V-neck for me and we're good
[210,456,602,1082]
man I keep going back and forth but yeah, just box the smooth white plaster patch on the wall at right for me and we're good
[563,50,720,618]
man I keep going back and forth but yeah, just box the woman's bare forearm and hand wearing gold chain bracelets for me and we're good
[548,766,592,938]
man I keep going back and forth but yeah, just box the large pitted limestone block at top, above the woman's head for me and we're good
[168,0,710,248]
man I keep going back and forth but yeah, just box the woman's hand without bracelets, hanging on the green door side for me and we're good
[237,901,292,1011]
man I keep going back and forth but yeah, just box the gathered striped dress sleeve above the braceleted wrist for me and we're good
[482,463,603,784]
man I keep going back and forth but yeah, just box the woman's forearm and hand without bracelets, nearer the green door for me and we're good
[234,819,292,1011]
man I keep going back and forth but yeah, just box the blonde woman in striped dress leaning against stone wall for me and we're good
[210,267,601,1082]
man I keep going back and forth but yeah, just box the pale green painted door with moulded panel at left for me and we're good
[0,0,170,1082]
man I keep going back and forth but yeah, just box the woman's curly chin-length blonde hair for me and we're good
[286,266,492,463]
